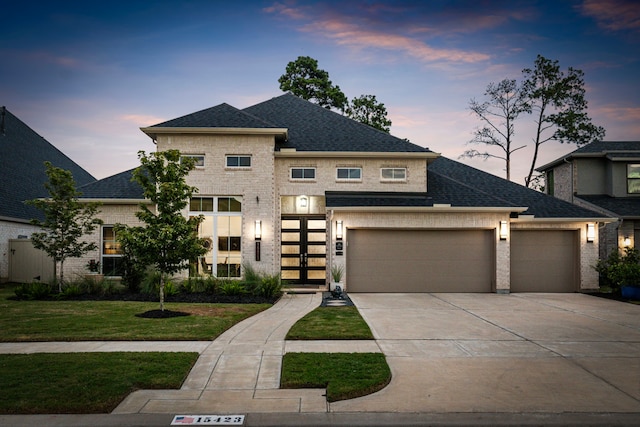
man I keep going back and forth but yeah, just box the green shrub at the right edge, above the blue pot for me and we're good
[594,248,640,292]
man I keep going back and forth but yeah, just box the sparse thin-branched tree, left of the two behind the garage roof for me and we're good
[460,79,530,180]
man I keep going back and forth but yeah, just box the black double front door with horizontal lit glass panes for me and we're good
[280,215,327,285]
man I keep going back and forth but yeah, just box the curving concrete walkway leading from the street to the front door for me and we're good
[113,293,380,414]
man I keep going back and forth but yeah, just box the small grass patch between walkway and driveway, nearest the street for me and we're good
[280,353,391,402]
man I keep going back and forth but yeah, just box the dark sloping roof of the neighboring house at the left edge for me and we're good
[0,107,95,281]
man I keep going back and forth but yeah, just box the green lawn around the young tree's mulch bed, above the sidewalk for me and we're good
[0,287,271,342]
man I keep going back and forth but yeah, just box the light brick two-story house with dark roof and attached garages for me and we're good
[75,94,611,293]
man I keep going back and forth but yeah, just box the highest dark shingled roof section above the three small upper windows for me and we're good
[242,93,430,153]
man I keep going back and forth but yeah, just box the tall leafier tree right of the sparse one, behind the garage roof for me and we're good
[522,55,605,187]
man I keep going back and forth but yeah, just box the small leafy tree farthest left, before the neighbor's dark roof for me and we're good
[27,162,102,292]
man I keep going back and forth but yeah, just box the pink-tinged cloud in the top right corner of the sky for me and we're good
[579,0,640,31]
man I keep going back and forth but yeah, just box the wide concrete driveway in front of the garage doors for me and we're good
[330,294,640,413]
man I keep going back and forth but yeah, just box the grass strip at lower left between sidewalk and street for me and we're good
[0,352,198,414]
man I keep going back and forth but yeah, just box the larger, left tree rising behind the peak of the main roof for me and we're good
[278,56,348,111]
